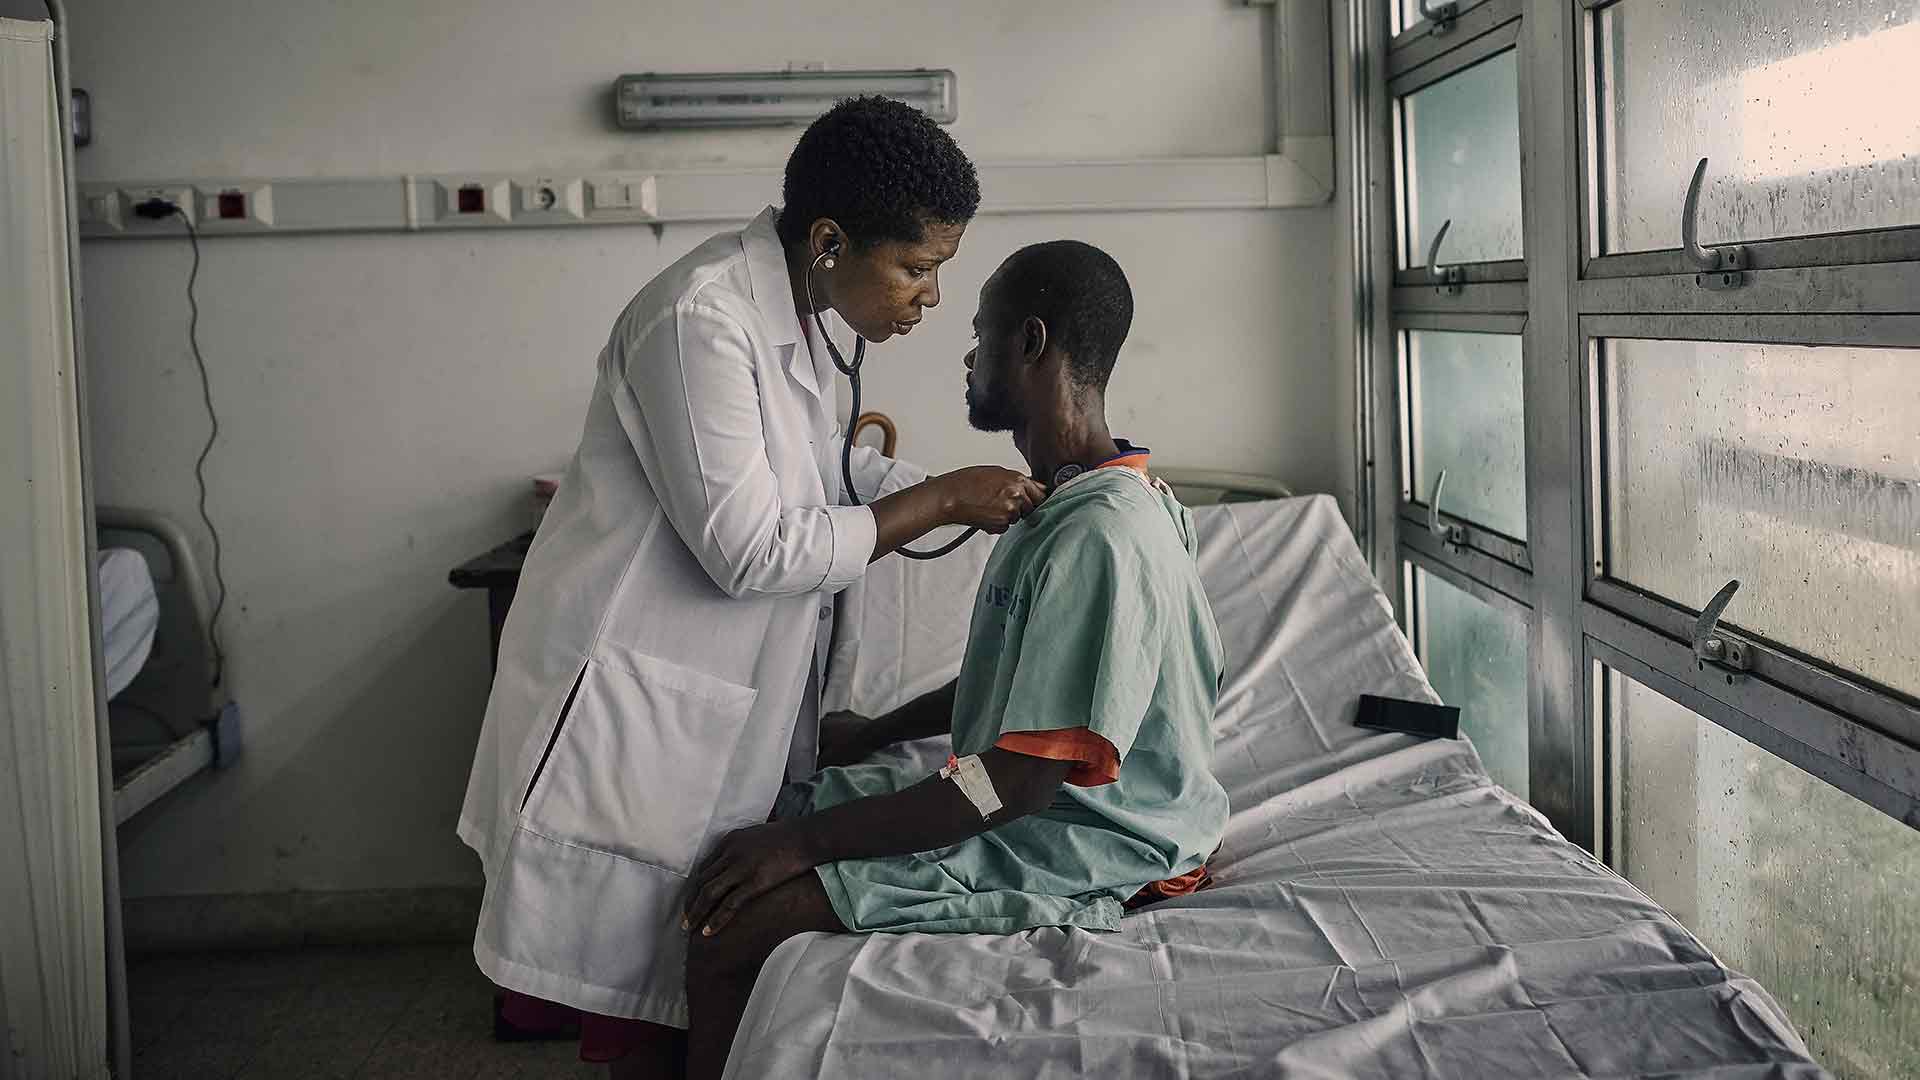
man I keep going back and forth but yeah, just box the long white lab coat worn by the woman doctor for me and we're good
[459,209,924,1026]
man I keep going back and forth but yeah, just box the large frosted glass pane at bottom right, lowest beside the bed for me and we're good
[1609,673,1920,1080]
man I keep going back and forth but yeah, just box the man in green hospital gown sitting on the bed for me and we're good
[685,240,1227,1076]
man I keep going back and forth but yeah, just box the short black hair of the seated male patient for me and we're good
[983,240,1133,390]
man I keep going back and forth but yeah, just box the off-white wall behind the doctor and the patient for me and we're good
[73,0,1350,896]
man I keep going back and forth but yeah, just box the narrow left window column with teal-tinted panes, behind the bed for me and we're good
[1386,0,1532,799]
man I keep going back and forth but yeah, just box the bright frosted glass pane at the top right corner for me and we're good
[1599,0,1920,252]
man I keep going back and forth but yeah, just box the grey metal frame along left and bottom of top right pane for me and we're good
[1576,0,1920,297]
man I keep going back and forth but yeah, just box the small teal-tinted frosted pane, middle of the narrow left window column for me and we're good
[1405,322,1526,540]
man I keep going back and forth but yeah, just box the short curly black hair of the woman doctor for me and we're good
[780,96,979,246]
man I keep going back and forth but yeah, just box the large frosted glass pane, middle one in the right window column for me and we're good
[1605,340,1920,696]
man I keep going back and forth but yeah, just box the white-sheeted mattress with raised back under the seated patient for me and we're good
[728,496,1822,1080]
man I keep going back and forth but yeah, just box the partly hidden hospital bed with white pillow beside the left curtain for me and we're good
[94,505,240,824]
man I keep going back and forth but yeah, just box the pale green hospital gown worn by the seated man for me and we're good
[810,467,1227,934]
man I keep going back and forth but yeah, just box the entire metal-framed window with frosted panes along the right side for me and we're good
[1354,0,1920,1076]
